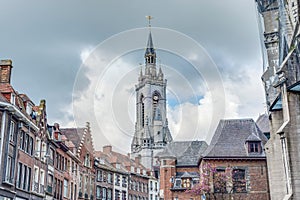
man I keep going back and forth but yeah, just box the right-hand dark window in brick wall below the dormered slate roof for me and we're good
[232,169,246,193]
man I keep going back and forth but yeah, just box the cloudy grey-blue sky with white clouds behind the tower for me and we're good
[0,0,265,152]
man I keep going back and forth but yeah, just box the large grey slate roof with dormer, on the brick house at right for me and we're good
[204,119,268,158]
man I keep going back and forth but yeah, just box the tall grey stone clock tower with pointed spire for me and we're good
[131,30,172,169]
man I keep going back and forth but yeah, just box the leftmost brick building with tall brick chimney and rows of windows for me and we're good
[0,60,46,199]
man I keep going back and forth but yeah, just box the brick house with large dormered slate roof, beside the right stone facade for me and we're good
[200,119,270,199]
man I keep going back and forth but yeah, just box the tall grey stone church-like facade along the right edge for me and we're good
[256,0,300,199]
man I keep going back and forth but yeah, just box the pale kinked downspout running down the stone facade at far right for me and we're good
[276,82,293,200]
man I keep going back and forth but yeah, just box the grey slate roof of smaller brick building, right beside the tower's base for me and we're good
[156,141,208,166]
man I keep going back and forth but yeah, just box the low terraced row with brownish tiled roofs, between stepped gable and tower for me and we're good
[95,145,150,200]
